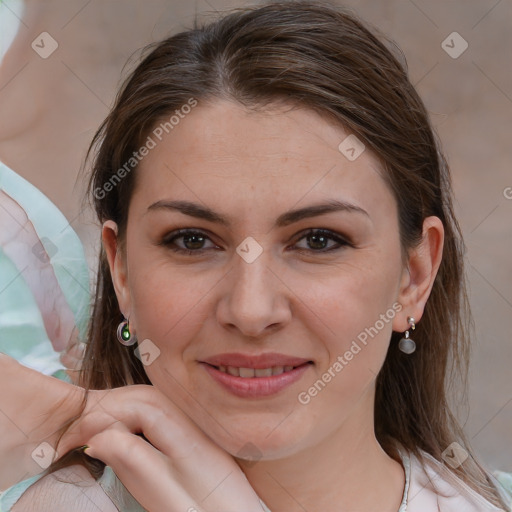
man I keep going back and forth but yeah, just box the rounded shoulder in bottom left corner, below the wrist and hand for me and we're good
[11,465,118,512]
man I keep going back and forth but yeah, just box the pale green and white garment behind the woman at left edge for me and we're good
[0,162,91,380]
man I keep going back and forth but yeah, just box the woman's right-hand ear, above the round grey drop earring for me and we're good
[393,216,444,332]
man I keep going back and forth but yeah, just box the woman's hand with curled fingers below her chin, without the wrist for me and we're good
[82,385,264,512]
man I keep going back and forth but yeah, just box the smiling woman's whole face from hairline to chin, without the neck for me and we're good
[104,101,412,459]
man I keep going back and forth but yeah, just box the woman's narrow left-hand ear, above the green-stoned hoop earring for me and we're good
[101,220,131,325]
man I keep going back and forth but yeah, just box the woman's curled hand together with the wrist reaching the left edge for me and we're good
[0,353,263,512]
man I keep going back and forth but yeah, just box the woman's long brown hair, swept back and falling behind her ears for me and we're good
[50,1,504,507]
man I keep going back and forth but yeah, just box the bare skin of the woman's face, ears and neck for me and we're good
[97,101,443,512]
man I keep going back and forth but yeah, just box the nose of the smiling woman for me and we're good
[217,247,291,338]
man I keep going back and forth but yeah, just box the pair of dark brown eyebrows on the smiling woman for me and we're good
[146,199,370,227]
